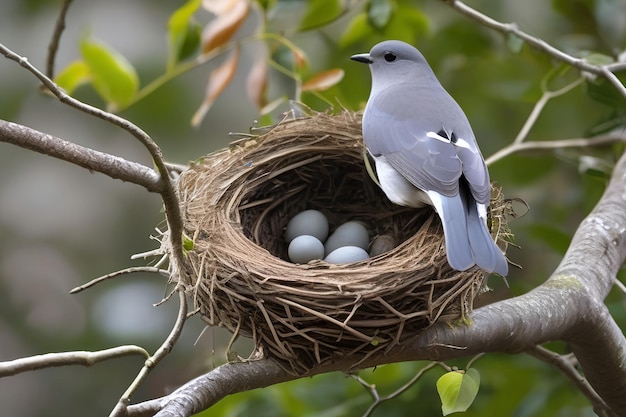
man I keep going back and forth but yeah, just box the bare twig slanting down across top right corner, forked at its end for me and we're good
[441,0,626,98]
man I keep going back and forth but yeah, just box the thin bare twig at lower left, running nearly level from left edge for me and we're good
[0,345,150,378]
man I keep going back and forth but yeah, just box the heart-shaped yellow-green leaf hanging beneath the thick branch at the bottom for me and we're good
[437,368,480,416]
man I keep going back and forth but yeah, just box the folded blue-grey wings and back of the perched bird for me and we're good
[363,82,490,204]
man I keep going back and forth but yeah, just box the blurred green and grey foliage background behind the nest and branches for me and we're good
[0,0,626,417]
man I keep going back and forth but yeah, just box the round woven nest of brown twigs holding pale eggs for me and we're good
[178,112,506,374]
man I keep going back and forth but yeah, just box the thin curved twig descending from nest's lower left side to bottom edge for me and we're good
[110,285,188,417]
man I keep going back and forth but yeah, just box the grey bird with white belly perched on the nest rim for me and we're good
[351,40,508,277]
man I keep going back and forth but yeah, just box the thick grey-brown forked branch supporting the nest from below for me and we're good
[128,147,626,417]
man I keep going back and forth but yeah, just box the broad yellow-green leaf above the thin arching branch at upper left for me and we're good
[80,38,139,110]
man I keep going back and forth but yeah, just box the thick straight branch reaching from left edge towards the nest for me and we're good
[0,120,162,193]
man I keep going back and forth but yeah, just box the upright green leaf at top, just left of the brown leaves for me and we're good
[167,0,202,71]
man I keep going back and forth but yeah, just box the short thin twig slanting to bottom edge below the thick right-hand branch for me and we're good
[526,345,617,417]
